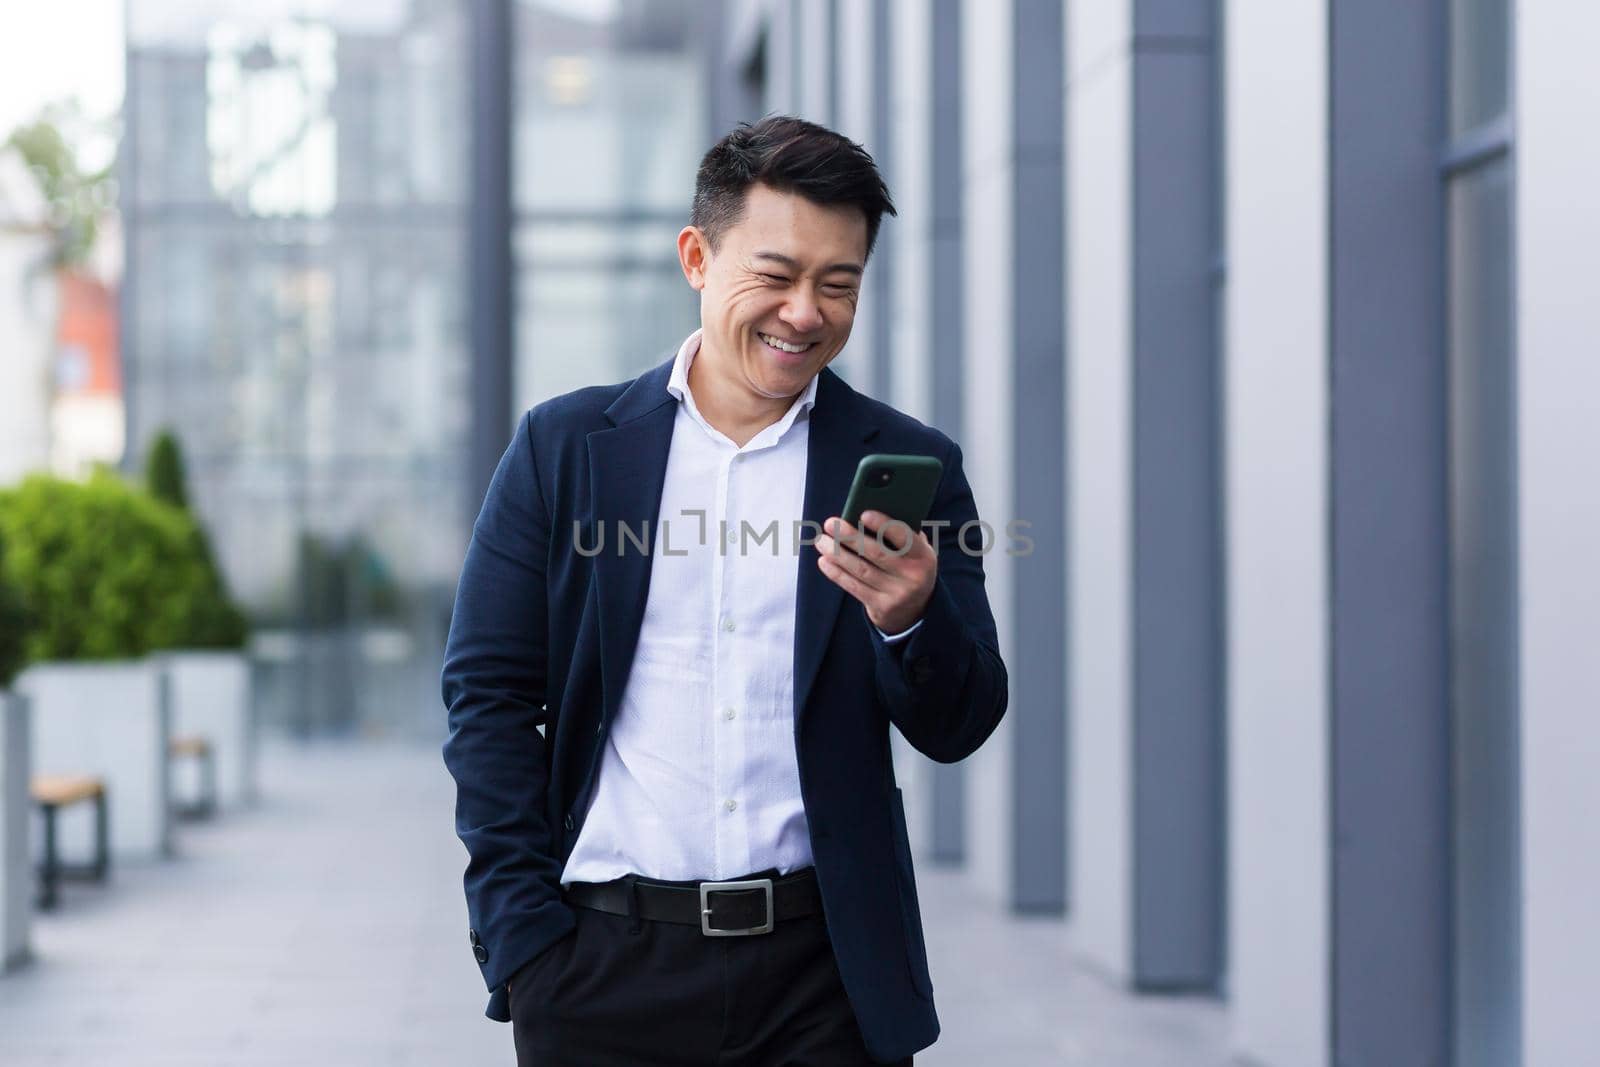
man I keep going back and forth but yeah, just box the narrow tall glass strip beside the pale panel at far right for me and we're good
[1446,0,1522,1067]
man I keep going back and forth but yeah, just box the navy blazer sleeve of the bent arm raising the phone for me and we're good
[872,442,1006,763]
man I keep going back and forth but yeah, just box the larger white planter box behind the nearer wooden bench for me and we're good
[16,659,173,862]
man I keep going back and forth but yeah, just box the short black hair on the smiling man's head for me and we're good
[690,115,894,256]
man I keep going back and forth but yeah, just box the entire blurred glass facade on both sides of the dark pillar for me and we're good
[123,0,714,731]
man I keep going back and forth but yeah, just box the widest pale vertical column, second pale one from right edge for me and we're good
[1222,0,1330,1067]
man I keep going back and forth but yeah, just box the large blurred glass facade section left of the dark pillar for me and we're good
[123,0,470,729]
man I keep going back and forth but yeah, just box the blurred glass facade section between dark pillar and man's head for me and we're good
[512,0,710,411]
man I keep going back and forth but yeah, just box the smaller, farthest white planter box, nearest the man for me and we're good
[165,651,256,808]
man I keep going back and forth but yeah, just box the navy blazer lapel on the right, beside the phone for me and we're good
[794,368,878,731]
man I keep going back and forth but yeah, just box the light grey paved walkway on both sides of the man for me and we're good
[0,741,1229,1067]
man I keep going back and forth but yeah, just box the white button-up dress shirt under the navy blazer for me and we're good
[562,330,915,885]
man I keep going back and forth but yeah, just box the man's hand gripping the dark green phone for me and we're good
[816,512,939,635]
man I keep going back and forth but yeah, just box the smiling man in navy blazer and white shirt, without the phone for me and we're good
[443,117,1006,1067]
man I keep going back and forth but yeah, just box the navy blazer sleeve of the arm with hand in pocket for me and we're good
[440,413,574,1022]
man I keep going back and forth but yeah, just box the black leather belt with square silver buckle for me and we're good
[565,867,822,937]
